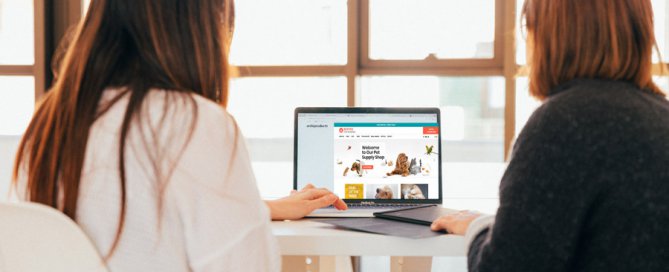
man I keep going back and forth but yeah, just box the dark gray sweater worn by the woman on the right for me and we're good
[469,79,669,271]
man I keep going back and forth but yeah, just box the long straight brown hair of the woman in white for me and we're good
[13,0,234,258]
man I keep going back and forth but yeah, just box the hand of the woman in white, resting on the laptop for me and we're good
[265,184,348,220]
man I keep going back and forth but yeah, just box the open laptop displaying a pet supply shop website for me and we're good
[293,108,442,217]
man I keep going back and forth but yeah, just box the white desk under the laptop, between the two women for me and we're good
[272,219,466,272]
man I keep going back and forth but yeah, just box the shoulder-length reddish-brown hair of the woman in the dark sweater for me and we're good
[523,0,664,99]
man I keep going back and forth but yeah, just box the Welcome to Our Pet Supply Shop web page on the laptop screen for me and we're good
[333,123,439,199]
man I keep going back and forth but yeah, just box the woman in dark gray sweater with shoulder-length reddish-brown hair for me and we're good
[432,0,669,271]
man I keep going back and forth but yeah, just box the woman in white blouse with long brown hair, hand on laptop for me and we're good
[14,0,346,271]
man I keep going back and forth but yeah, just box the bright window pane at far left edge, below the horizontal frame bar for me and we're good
[0,76,35,135]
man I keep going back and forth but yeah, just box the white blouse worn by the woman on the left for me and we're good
[20,90,281,272]
